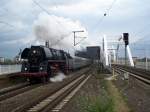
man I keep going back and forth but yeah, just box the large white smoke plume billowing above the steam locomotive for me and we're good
[34,13,88,52]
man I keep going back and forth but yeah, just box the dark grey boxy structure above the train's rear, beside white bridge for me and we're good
[87,46,100,60]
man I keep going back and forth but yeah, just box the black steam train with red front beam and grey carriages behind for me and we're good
[21,46,89,82]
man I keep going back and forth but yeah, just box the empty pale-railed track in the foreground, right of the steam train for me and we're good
[27,75,90,112]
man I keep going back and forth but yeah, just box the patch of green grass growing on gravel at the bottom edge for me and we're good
[79,93,114,112]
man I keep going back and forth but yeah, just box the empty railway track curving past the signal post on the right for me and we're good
[112,65,150,85]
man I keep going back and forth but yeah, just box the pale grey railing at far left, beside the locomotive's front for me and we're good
[0,64,21,75]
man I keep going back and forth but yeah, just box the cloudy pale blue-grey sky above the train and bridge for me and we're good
[0,0,150,57]
